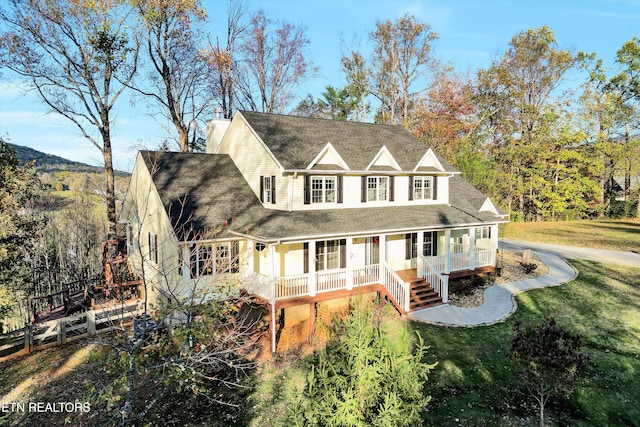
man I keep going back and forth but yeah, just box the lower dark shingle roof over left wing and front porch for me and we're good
[141,151,501,241]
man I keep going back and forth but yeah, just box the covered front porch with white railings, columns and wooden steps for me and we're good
[243,226,497,314]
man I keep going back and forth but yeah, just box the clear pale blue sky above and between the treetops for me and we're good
[0,0,640,171]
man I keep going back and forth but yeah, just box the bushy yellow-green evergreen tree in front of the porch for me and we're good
[291,302,436,427]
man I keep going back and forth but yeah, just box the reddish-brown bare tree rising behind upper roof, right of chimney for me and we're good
[236,10,316,113]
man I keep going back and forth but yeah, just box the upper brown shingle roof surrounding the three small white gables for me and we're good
[239,111,457,173]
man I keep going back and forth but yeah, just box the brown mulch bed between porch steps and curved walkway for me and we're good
[449,250,549,307]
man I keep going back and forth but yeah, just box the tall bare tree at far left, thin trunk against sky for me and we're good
[0,0,139,235]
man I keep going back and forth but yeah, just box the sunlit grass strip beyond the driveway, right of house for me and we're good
[502,218,640,251]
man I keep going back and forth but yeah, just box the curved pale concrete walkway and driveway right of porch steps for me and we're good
[408,240,640,327]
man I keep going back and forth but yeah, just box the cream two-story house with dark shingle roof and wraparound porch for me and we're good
[120,111,507,351]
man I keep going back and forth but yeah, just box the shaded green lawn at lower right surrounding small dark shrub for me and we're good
[412,261,640,426]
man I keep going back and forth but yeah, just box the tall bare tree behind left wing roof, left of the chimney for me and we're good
[134,0,218,152]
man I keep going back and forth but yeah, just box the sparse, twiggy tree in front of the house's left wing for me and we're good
[103,153,262,425]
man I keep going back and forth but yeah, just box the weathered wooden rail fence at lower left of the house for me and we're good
[0,301,142,362]
